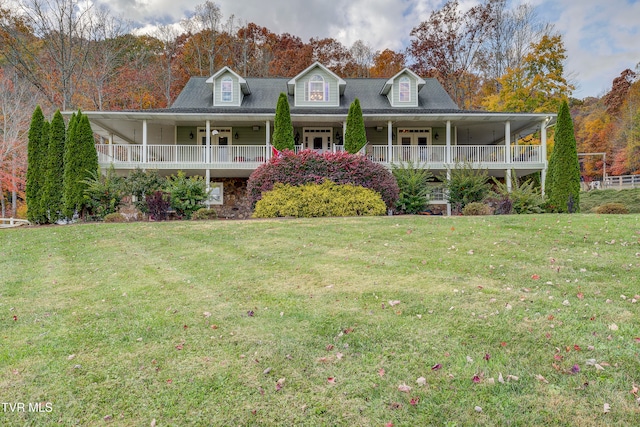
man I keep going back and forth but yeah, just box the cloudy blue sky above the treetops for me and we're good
[101,0,640,98]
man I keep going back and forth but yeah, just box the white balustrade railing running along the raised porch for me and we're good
[96,144,544,170]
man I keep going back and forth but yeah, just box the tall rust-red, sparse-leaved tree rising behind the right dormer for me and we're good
[407,0,495,108]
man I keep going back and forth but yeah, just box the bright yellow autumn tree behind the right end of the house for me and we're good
[484,35,574,113]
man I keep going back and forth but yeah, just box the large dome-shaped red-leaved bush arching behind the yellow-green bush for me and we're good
[247,150,399,208]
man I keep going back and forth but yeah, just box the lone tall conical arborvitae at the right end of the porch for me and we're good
[545,101,580,213]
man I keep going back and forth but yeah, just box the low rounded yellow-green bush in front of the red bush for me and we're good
[253,180,387,218]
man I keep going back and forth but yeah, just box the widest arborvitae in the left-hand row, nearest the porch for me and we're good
[64,111,99,218]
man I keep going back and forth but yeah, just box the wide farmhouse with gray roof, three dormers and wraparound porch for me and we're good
[79,62,556,216]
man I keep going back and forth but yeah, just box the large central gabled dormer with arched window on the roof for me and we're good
[287,61,347,107]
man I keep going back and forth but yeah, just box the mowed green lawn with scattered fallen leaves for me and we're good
[0,214,640,426]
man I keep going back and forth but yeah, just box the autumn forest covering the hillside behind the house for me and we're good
[0,0,640,217]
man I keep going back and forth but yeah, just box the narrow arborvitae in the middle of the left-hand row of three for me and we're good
[42,110,66,223]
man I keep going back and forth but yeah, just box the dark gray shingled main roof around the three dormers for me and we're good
[170,77,460,115]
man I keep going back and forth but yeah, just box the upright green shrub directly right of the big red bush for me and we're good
[391,163,433,214]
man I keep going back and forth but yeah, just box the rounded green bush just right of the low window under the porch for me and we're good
[444,164,490,212]
